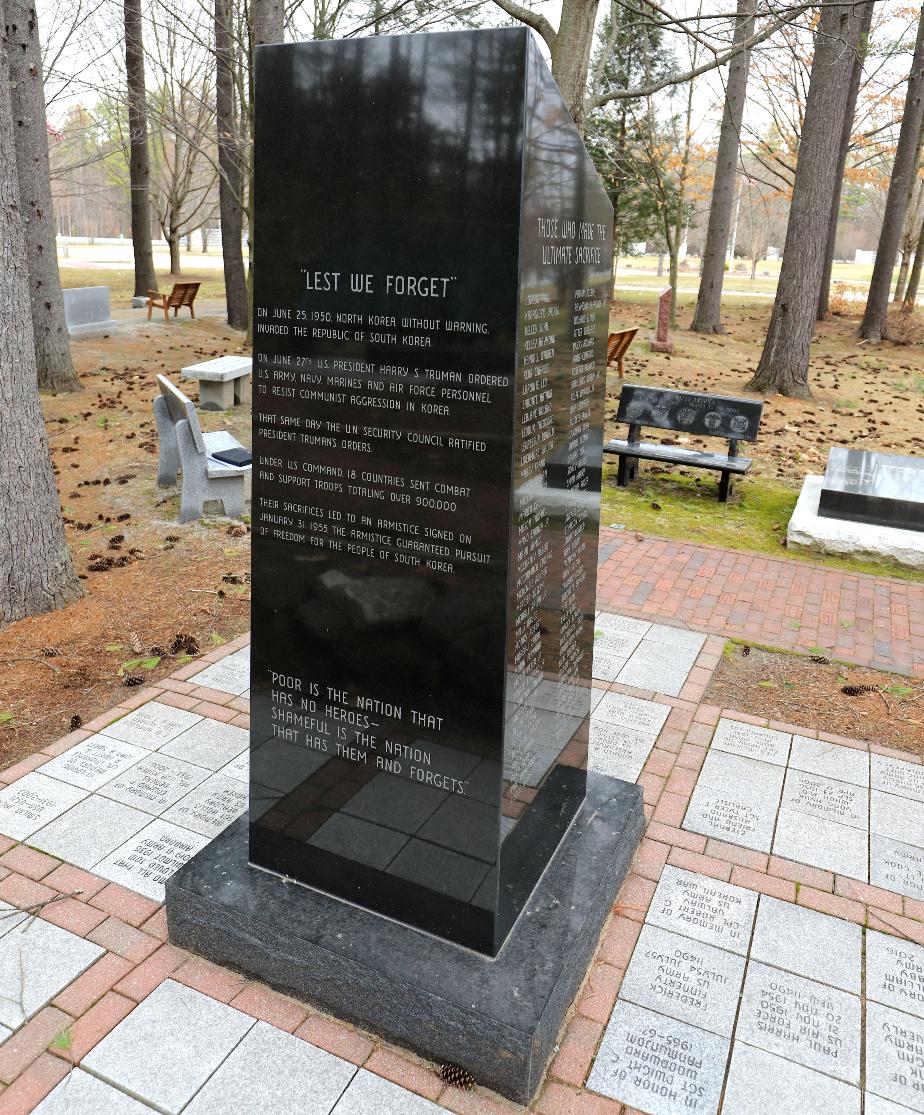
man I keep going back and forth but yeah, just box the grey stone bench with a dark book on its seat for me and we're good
[154,376,252,523]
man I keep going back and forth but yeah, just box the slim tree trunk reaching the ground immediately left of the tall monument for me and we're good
[215,0,247,329]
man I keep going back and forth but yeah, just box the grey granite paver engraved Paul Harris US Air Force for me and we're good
[735,960,860,1084]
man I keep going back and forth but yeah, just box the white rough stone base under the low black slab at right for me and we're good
[786,476,924,569]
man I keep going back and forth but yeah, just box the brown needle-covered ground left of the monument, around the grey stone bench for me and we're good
[0,318,250,767]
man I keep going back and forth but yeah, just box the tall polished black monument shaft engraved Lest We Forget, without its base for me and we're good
[250,28,612,954]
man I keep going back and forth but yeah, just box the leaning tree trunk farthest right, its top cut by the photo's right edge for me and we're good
[859,9,924,341]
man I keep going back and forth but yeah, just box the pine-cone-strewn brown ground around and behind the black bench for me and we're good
[606,299,924,485]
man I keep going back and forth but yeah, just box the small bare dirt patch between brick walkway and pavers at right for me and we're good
[704,643,924,756]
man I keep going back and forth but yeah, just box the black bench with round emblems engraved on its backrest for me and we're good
[603,384,763,503]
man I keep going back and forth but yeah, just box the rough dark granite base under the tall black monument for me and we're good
[166,774,644,1103]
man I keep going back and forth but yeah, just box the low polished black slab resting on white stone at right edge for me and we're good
[818,446,924,531]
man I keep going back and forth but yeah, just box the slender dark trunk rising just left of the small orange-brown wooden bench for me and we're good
[124,0,157,299]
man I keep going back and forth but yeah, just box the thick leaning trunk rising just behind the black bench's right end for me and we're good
[748,3,863,399]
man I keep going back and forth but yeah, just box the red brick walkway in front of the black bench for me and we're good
[597,530,924,677]
